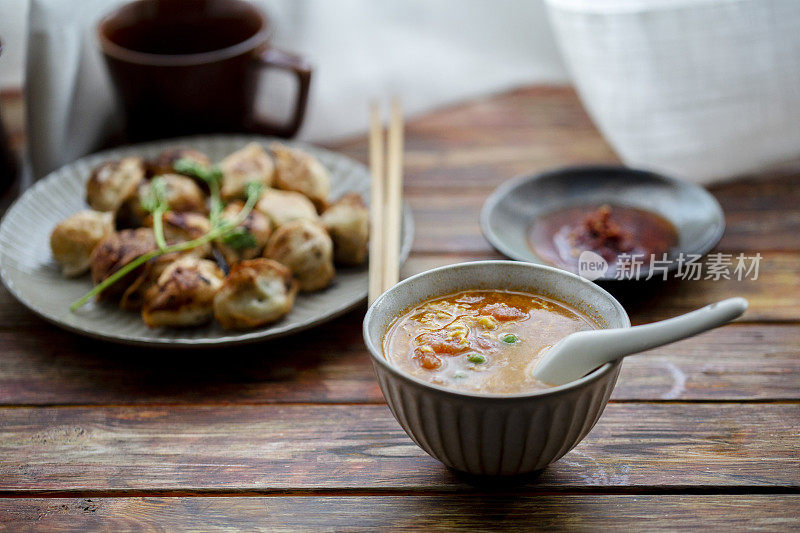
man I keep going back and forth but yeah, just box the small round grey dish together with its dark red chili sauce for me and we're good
[481,166,725,281]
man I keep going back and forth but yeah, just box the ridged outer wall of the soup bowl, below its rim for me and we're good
[374,356,619,475]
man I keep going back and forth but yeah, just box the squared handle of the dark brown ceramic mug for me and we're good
[248,47,311,137]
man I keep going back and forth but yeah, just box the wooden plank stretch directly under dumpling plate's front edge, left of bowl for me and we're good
[0,308,383,404]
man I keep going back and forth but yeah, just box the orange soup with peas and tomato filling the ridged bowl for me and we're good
[383,291,598,394]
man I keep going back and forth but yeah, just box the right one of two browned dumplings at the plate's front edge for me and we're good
[214,258,297,329]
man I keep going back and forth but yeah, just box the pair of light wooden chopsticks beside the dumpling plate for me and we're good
[369,99,403,303]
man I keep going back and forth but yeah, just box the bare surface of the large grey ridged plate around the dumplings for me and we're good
[0,135,414,347]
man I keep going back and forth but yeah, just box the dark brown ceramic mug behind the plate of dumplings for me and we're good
[98,0,311,140]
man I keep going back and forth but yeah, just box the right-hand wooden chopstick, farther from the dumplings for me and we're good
[383,99,403,291]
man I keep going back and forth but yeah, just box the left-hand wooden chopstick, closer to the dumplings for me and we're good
[369,102,385,304]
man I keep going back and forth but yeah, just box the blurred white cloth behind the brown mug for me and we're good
[26,0,566,176]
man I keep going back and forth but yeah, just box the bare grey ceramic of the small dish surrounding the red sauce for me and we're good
[481,166,725,279]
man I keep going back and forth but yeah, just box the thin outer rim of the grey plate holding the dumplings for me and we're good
[0,133,414,349]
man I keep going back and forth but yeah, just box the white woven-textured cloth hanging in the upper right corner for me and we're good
[547,0,800,182]
